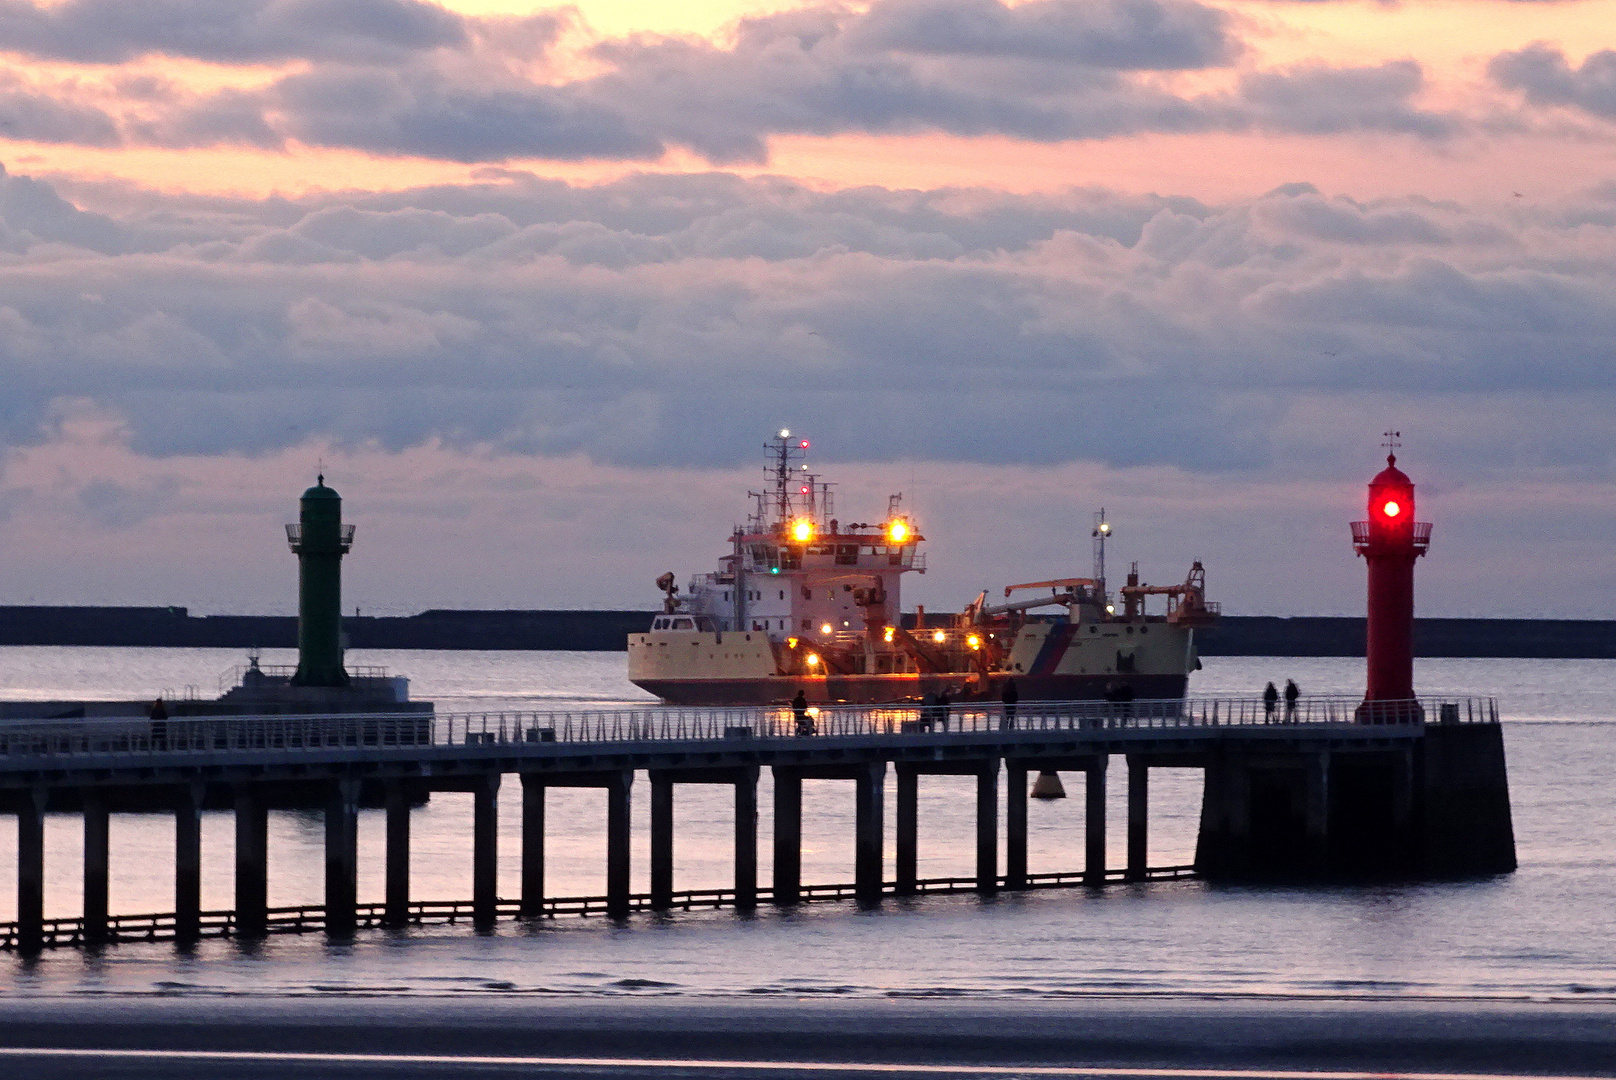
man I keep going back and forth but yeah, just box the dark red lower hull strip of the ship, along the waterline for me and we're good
[633,673,1189,705]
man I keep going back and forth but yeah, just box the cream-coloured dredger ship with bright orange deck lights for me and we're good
[629,428,1218,705]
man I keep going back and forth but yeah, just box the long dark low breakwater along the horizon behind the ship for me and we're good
[0,606,1616,660]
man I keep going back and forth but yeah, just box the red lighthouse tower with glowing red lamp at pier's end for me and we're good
[1353,432,1430,723]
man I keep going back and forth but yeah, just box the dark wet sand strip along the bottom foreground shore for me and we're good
[0,994,1616,1080]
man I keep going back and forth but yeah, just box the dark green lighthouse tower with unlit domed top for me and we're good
[286,474,354,686]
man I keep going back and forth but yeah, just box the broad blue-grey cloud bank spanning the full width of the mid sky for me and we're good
[0,166,1616,475]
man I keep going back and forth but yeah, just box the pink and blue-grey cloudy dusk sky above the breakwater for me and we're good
[0,0,1616,618]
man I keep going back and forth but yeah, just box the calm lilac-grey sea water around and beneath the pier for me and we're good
[0,648,1616,1001]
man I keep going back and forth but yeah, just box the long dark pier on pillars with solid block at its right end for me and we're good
[0,698,1514,952]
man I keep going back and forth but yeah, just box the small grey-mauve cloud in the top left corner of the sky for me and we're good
[0,0,467,63]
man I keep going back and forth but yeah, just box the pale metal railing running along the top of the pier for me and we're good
[0,697,1498,763]
